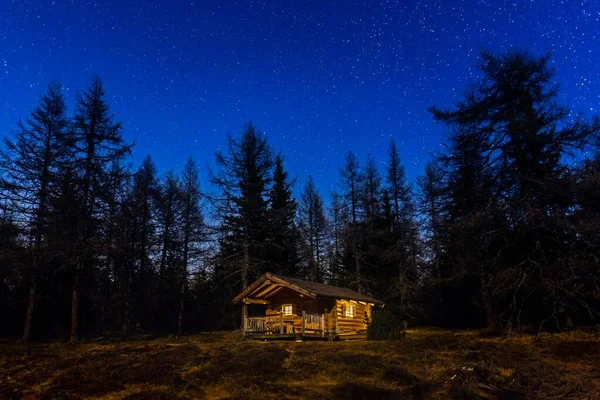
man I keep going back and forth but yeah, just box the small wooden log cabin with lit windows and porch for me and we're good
[233,273,383,340]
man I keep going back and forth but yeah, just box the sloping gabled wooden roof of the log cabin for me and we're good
[233,272,383,304]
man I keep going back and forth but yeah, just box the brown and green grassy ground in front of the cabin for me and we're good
[0,329,600,400]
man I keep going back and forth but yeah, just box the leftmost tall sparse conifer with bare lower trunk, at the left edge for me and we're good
[0,82,70,342]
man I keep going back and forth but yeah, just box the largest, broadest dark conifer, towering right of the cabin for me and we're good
[432,51,600,331]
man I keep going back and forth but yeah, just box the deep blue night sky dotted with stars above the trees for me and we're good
[0,0,600,195]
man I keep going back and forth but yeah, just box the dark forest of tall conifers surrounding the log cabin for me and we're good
[0,51,600,342]
